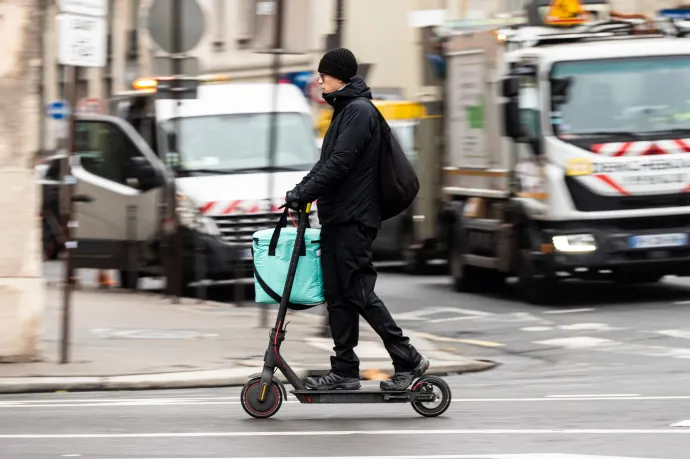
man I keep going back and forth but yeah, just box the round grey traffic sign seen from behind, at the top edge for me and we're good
[147,0,205,53]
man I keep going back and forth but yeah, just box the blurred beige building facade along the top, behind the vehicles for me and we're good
[40,0,683,150]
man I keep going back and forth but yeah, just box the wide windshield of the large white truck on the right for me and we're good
[551,56,690,138]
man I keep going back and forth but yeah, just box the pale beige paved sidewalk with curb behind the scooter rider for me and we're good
[0,286,495,393]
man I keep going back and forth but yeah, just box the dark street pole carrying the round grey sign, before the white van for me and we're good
[167,0,183,303]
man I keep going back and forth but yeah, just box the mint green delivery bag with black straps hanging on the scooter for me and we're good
[252,209,326,310]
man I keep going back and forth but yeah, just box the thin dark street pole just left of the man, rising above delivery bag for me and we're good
[260,0,287,328]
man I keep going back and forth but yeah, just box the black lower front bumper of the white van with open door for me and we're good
[182,228,254,282]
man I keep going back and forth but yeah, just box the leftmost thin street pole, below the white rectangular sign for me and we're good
[60,66,77,364]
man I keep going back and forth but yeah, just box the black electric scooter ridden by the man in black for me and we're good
[240,203,451,418]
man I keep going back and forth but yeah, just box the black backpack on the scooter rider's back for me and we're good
[366,99,419,221]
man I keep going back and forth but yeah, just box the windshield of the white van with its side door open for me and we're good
[161,113,318,173]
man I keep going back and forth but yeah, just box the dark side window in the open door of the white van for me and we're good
[76,121,142,189]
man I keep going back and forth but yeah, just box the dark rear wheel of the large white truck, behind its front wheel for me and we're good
[448,226,505,293]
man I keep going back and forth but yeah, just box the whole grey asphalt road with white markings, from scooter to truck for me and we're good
[36,262,690,459]
